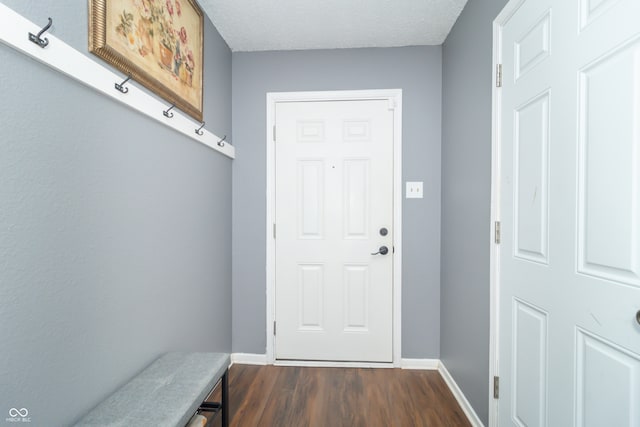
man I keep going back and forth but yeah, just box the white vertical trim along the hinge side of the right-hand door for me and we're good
[488,0,525,427]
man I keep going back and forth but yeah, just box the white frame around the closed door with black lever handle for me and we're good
[266,89,403,367]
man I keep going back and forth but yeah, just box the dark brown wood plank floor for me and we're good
[205,365,470,427]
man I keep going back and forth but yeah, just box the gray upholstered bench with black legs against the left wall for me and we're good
[76,353,231,427]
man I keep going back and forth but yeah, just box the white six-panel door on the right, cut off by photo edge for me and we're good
[498,0,640,427]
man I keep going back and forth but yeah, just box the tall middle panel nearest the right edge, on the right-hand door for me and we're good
[578,41,640,286]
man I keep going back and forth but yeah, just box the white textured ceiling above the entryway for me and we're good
[199,0,467,52]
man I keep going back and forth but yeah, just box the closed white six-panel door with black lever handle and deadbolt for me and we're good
[275,99,393,362]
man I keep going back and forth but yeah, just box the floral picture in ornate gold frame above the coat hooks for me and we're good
[89,0,204,121]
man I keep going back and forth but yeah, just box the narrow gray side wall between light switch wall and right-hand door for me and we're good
[440,0,507,424]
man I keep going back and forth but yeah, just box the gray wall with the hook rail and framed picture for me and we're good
[0,0,232,426]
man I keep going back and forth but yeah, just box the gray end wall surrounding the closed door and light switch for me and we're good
[233,46,442,358]
